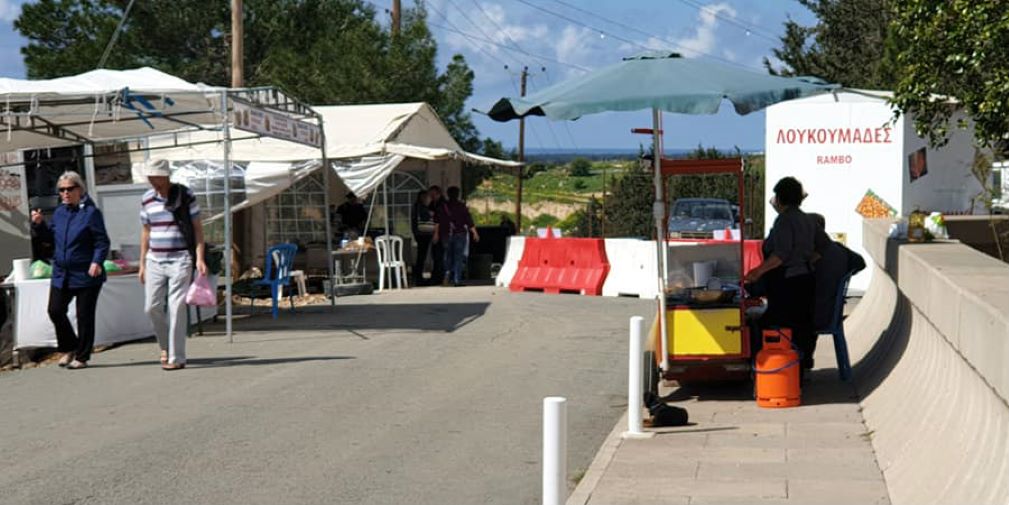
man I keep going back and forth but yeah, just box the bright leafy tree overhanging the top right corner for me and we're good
[893,0,1009,156]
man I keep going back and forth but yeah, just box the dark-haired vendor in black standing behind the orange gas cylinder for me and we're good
[745,177,825,370]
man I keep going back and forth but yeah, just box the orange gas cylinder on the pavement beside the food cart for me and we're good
[754,328,801,408]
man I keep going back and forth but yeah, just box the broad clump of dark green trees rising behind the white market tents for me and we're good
[14,0,490,152]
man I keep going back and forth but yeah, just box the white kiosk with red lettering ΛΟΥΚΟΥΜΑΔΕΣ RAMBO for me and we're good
[764,93,980,292]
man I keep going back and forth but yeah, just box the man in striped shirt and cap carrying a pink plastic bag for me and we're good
[139,160,207,370]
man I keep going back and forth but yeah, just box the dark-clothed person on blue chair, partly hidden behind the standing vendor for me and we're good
[808,213,866,329]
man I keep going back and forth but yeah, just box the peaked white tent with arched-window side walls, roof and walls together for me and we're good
[132,102,522,284]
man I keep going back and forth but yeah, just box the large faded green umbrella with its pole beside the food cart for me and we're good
[487,53,838,370]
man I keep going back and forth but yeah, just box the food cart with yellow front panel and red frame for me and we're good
[645,159,763,393]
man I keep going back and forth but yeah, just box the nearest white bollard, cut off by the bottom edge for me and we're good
[542,396,567,505]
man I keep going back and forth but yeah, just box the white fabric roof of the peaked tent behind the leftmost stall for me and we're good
[133,102,522,200]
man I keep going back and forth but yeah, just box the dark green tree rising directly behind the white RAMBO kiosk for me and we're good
[764,0,900,89]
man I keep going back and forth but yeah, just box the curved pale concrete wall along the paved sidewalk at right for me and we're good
[846,220,1009,505]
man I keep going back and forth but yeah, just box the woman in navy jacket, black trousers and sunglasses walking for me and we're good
[31,172,109,370]
